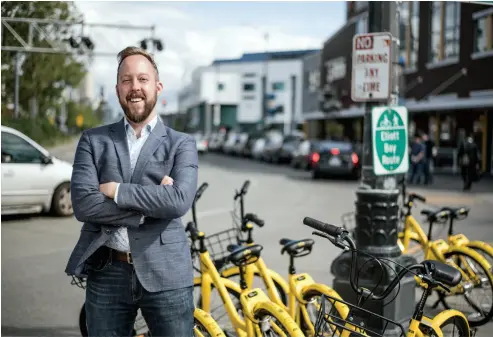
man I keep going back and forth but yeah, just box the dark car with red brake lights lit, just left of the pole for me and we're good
[311,140,361,179]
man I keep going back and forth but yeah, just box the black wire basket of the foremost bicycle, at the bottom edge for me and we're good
[315,295,406,337]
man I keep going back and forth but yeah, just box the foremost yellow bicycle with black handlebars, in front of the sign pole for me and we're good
[303,217,471,337]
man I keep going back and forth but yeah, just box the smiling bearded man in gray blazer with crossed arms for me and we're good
[66,47,198,337]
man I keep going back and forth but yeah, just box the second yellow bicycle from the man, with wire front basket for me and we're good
[187,180,348,336]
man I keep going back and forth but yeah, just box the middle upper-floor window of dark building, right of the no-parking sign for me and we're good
[429,1,460,62]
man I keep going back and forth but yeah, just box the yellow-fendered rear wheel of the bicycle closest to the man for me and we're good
[253,302,305,337]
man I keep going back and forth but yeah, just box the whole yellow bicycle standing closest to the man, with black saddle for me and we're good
[186,218,304,337]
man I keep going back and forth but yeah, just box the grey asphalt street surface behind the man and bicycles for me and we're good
[2,144,493,337]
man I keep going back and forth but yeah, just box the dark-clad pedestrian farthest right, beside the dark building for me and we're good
[457,135,481,191]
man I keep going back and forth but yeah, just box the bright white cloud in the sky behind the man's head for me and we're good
[76,1,340,111]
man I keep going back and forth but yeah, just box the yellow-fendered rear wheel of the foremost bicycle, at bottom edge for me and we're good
[426,310,471,337]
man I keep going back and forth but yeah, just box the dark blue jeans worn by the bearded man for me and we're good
[86,260,195,337]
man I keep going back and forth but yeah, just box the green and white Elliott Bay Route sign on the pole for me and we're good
[371,106,409,176]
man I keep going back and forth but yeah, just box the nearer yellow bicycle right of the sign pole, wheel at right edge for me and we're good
[398,193,493,327]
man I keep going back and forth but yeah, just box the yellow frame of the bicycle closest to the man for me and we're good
[194,240,299,337]
